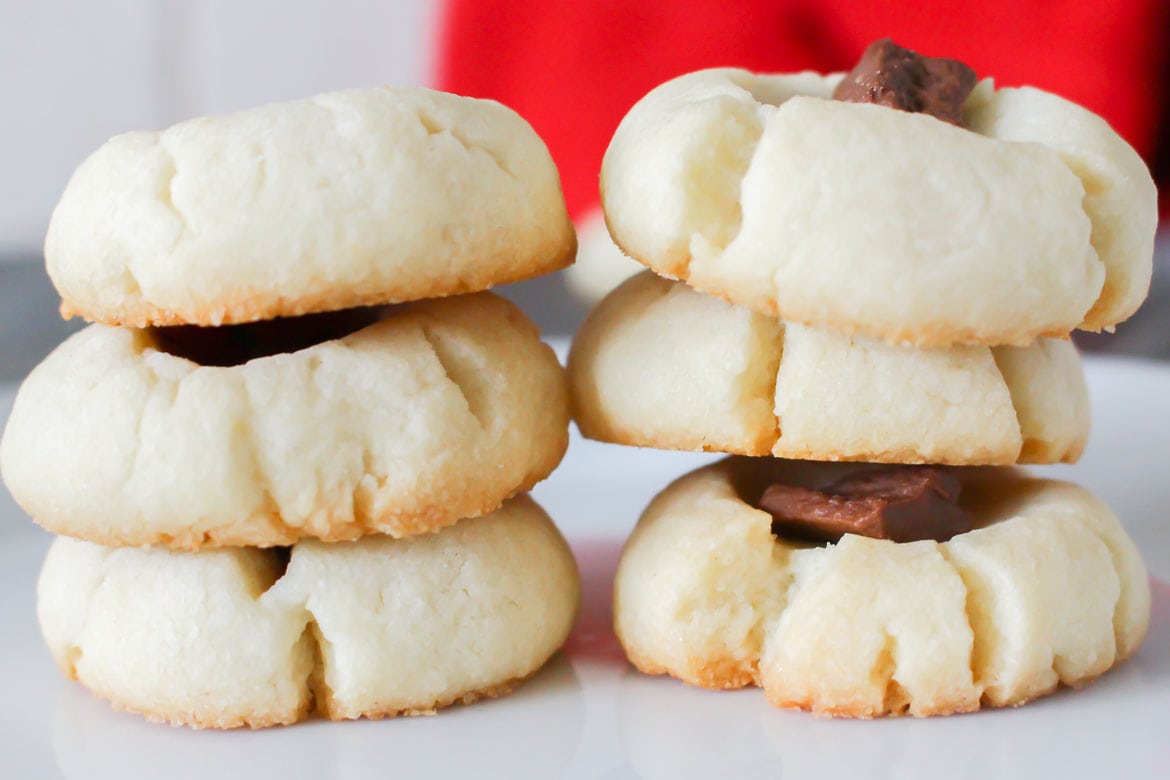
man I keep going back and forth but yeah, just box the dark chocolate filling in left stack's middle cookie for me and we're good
[149,306,388,366]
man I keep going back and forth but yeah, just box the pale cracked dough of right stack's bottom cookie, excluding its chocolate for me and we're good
[614,458,1150,718]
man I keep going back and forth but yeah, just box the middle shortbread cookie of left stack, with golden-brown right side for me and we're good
[0,292,569,548]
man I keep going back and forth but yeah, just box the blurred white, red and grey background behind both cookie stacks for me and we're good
[0,0,1170,382]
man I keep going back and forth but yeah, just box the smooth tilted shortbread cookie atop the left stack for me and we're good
[44,88,576,326]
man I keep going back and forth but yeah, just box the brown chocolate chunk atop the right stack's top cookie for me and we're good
[833,37,978,126]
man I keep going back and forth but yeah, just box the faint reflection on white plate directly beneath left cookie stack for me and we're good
[51,656,585,780]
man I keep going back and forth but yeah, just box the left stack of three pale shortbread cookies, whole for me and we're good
[0,89,579,727]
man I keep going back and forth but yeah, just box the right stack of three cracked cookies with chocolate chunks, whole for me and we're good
[570,41,1156,717]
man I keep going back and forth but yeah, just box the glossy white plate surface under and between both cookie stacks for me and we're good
[0,359,1170,780]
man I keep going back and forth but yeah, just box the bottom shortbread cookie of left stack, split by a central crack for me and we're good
[37,496,579,729]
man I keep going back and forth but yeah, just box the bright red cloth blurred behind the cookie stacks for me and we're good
[435,0,1170,216]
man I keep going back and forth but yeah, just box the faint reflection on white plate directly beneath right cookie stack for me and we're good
[617,580,1170,780]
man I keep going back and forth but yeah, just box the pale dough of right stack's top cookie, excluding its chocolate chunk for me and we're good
[601,69,1157,346]
